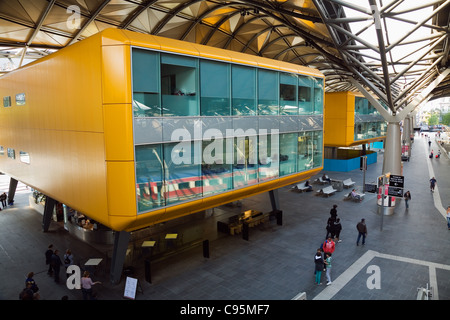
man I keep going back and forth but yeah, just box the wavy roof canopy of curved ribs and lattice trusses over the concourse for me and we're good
[0,0,450,113]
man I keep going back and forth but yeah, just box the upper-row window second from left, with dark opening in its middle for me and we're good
[161,53,199,116]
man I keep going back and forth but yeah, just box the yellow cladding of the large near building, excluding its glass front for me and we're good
[0,29,323,231]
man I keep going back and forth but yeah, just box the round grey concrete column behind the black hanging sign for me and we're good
[382,122,402,215]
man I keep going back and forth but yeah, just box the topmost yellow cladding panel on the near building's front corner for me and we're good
[101,45,131,104]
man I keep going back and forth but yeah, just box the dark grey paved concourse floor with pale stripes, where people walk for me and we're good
[0,131,450,300]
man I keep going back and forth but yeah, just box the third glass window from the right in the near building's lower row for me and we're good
[280,133,298,176]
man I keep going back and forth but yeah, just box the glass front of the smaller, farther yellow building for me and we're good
[354,97,387,141]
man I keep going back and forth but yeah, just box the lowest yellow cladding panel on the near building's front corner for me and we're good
[106,161,136,221]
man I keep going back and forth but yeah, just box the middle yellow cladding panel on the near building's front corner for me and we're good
[103,104,134,161]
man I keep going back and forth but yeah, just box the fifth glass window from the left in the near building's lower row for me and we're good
[258,133,279,181]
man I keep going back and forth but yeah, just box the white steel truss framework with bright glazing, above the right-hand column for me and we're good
[313,0,450,118]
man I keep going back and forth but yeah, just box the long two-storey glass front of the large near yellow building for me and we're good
[132,48,323,213]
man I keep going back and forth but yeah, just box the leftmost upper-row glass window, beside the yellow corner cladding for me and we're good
[132,48,161,117]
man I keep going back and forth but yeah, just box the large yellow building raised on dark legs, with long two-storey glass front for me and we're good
[0,29,324,231]
